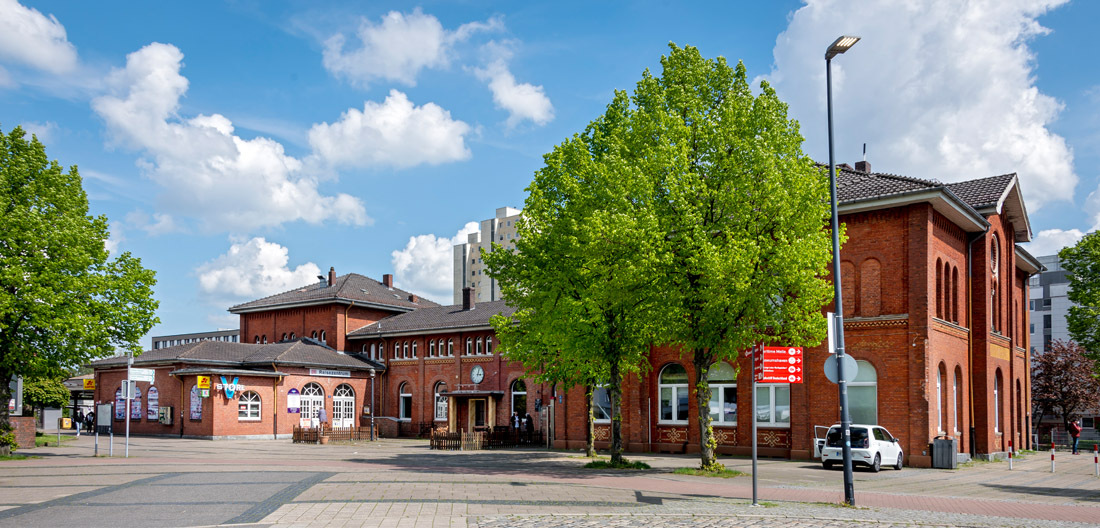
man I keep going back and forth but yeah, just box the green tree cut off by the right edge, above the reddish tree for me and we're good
[1058,231,1100,358]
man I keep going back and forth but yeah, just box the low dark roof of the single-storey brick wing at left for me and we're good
[91,338,385,371]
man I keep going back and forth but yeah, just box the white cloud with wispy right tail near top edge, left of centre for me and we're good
[323,8,504,87]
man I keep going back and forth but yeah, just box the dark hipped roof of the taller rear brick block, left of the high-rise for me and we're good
[229,273,439,314]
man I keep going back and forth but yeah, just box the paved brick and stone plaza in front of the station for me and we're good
[0,436,1100,528]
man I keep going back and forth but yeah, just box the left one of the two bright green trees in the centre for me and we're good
[484,92,661,464]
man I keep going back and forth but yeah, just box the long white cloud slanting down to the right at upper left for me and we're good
[92,43,370,232]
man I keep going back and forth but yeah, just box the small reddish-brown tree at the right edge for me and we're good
[1032,339,1100,422]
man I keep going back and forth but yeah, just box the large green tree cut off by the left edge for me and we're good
[0,127,158,442]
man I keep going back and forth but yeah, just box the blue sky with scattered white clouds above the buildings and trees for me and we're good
[0,0,1100,345]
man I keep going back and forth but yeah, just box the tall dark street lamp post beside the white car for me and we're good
[825,35,859,506]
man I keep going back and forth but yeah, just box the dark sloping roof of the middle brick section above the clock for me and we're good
[348,300,516,338]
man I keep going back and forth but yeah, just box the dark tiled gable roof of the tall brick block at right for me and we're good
[836,165,1031,242]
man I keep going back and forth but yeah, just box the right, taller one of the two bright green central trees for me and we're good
[630,44,832,471]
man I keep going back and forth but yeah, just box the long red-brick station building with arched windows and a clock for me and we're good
[90,162,1042,466]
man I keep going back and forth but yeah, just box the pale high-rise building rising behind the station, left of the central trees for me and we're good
[454,207,523,305]
